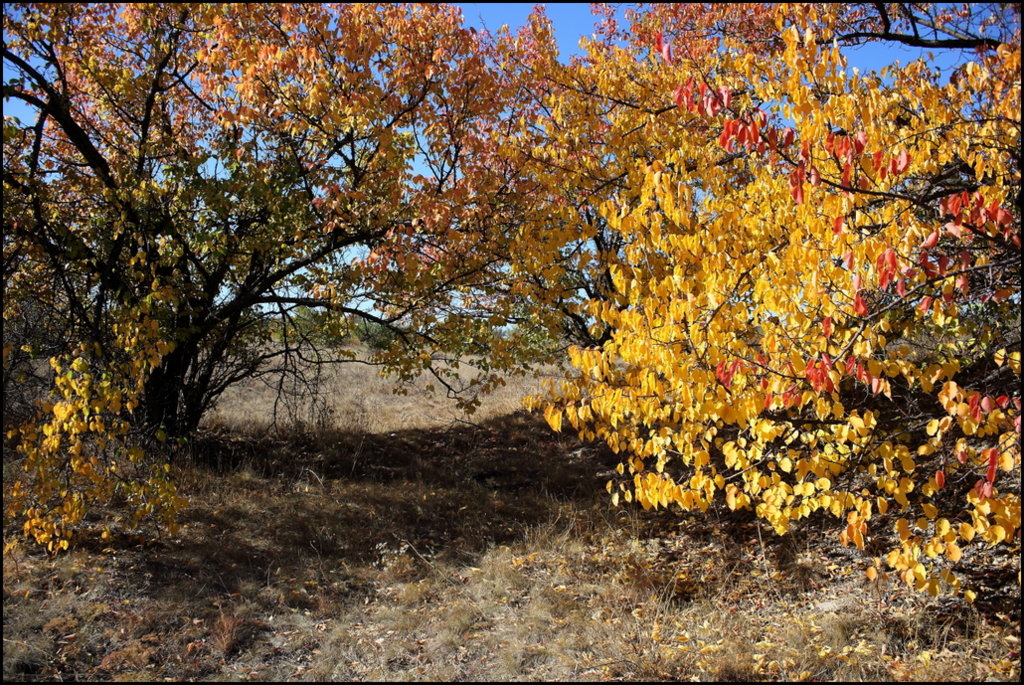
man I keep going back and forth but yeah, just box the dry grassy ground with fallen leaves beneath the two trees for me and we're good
[3,358,1020,681]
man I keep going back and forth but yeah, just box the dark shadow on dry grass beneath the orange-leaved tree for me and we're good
[90,413,617,609]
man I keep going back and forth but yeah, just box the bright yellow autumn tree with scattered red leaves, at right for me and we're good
[516,3,1021,593]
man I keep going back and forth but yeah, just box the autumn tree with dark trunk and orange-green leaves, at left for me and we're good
[3,3,536,549]
